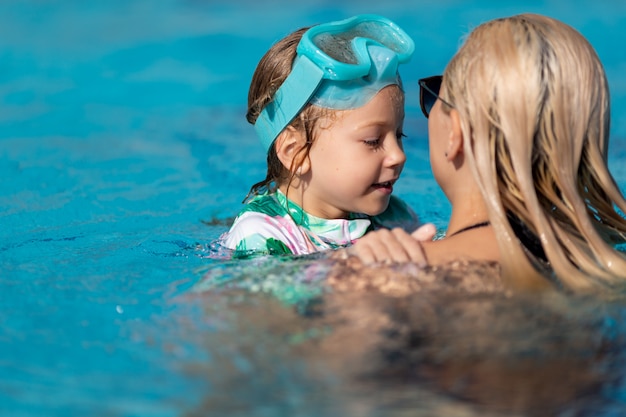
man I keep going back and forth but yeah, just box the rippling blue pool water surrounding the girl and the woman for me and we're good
[0,0,626,417]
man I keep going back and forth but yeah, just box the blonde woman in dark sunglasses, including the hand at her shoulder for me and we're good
[351,14,626,291]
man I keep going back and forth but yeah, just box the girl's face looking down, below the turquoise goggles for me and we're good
[301,86,406,219]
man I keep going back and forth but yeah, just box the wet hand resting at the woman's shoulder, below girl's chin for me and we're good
[349,224,435,266]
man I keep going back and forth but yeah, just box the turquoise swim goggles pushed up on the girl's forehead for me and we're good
[254,15,415,150]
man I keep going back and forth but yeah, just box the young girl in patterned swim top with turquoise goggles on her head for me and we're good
[221,15,418,257]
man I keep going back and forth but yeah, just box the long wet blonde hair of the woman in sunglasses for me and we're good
[442,14,626,291]
